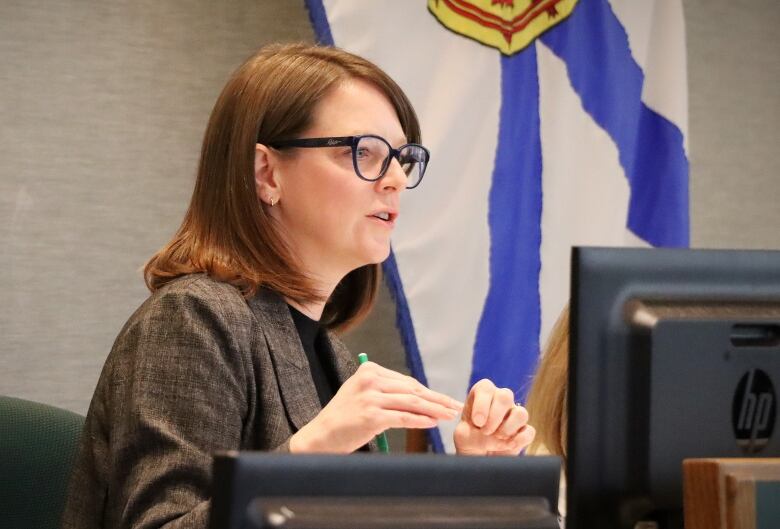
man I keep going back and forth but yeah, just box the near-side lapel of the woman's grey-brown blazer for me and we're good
[249,290,322,430]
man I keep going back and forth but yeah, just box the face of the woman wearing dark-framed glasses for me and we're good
[270,79,406,281]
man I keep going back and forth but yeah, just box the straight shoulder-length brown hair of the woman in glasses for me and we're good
[144,44,420,329]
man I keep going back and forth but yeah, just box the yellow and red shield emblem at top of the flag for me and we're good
[428,0,578,55]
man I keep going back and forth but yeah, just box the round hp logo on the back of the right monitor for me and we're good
[731,369,777,454]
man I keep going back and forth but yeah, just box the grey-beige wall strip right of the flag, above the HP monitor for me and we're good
[684,0,780,249]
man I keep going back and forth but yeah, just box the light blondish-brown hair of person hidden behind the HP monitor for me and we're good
[526,305,569,462]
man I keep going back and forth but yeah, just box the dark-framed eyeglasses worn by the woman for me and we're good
[269,134,431,189]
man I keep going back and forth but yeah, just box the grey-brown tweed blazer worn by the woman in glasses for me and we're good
[62,274,375,529]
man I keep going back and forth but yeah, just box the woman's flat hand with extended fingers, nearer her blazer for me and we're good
[290,362,463,453]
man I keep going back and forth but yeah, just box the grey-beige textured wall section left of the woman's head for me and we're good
[0,0,313,412]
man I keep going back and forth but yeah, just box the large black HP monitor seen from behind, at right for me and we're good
[567,248,780,529]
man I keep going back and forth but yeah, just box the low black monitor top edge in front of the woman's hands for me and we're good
[210,452,561,529]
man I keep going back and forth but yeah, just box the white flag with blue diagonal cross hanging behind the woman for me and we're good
[307,0,689,451]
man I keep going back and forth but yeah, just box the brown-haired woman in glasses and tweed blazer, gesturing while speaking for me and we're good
[64,45,533,528]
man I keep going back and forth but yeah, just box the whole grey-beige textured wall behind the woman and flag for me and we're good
[0,0,780,434]
